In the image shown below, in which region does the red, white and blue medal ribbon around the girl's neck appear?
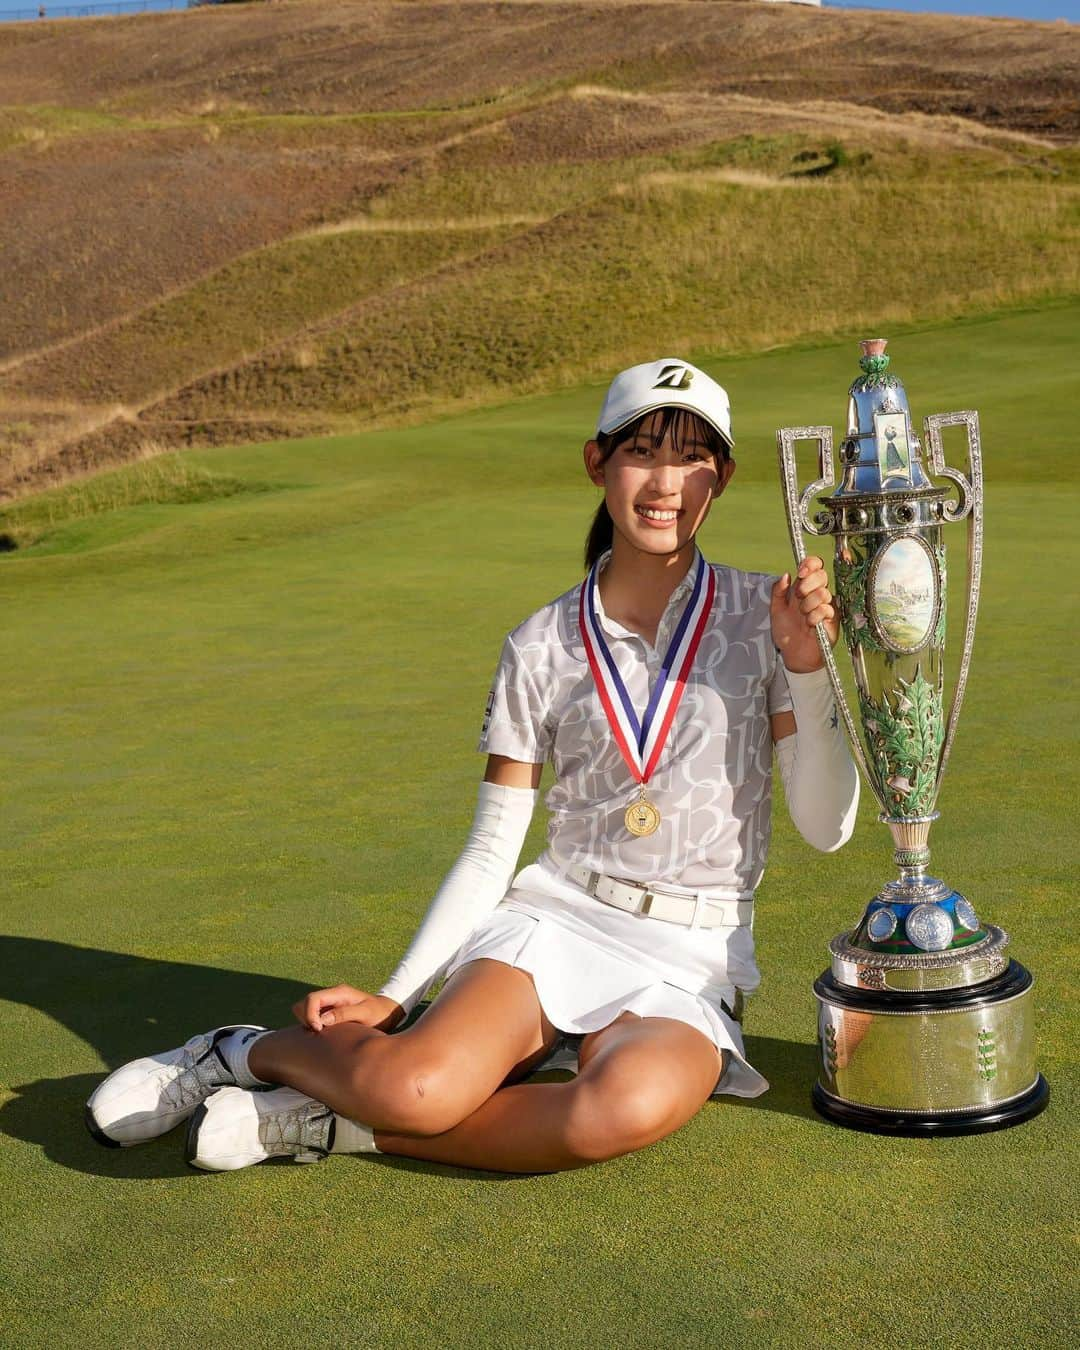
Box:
[578,554,717,787]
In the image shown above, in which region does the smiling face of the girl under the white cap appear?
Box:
[585,409,734,556]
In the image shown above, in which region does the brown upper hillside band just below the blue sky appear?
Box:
[0,0,1080,136]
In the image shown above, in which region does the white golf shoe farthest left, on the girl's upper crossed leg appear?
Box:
[86,1026,266,1149]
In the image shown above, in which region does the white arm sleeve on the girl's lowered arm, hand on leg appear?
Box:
[379,783,537,1013]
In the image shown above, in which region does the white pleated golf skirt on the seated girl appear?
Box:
[447,855,768,1098]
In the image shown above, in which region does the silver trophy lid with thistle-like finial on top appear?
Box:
[834,338,932,497]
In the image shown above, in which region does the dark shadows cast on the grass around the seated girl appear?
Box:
[0,936,817,1180]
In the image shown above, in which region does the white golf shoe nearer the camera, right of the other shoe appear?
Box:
[186,1088,336,1172]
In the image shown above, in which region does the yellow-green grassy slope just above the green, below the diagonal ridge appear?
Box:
[155,149,1080,415]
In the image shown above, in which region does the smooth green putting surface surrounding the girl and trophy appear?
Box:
[0,306,1077,1347]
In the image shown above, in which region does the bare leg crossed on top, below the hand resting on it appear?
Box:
[248,960,558,1134]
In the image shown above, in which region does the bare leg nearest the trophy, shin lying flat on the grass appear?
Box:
[375,1013,724,1172]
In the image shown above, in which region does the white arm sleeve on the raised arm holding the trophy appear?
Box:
[776,670,859,853]
